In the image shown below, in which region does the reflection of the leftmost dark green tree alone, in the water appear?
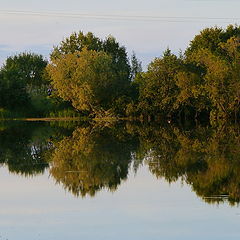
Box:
[0,123,49,176]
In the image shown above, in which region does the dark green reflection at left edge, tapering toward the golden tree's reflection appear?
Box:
[0,121,73,177]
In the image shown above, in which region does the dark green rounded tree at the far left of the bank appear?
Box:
[0,53,47,109]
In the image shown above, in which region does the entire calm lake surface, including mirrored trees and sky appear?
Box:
[0,122,240,240]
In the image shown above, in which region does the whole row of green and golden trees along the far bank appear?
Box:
[0,25,240,122]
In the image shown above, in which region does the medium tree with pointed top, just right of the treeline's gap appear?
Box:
[136,49,182,116]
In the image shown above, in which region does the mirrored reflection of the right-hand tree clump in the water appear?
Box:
[135,124,240,204]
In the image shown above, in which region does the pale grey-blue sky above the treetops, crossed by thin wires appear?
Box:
[0,0,240,66]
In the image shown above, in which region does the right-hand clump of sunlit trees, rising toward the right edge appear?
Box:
[133,25,240,121]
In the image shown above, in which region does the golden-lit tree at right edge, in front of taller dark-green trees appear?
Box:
[183,37,240,120]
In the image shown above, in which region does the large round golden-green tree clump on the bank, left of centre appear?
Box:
[48,32,131,116]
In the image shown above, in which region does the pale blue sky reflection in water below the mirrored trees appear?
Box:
[0,165,240,240]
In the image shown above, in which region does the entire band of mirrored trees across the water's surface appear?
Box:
[0,122,240,204]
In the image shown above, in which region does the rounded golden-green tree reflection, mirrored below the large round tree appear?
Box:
[50,126,137,196]
